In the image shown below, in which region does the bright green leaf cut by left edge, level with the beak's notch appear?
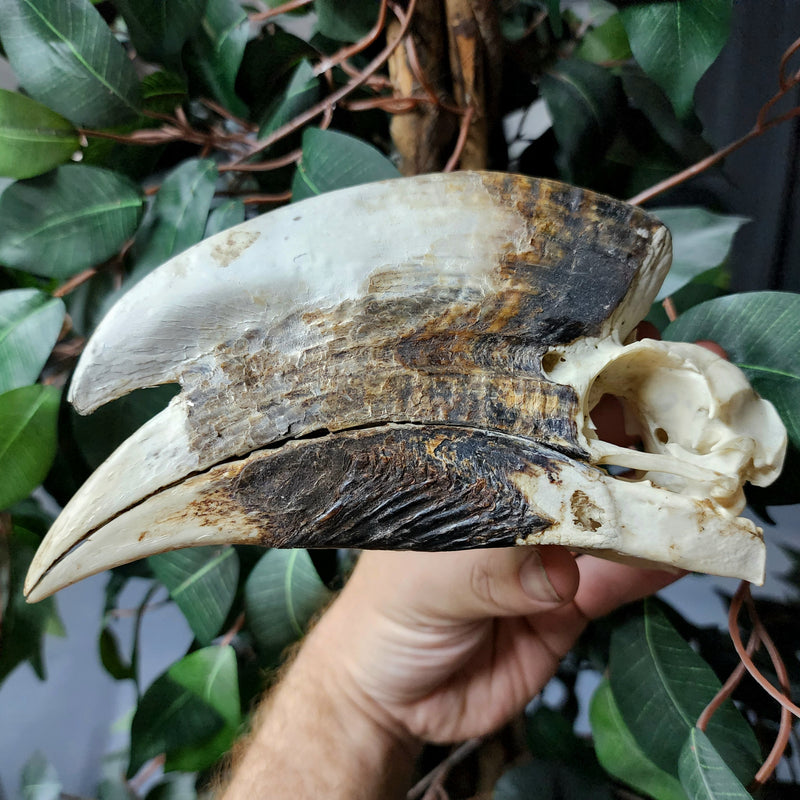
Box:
[0,384,61,510]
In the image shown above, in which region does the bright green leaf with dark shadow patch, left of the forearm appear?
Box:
[127,646,241,778]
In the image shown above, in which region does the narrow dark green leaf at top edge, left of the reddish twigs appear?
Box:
[186,0,250,116]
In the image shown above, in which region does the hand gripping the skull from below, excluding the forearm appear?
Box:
[315,547,677,742]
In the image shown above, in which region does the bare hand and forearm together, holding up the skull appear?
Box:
[225,547,676,800]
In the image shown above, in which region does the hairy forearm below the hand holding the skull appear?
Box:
[219,600,418,800]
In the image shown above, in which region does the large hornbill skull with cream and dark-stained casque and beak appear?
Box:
[26,173,786,600]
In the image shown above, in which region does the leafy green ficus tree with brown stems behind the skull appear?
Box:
[0,0,800,800]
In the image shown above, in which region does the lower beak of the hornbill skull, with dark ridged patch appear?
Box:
[21,424,764,601]
